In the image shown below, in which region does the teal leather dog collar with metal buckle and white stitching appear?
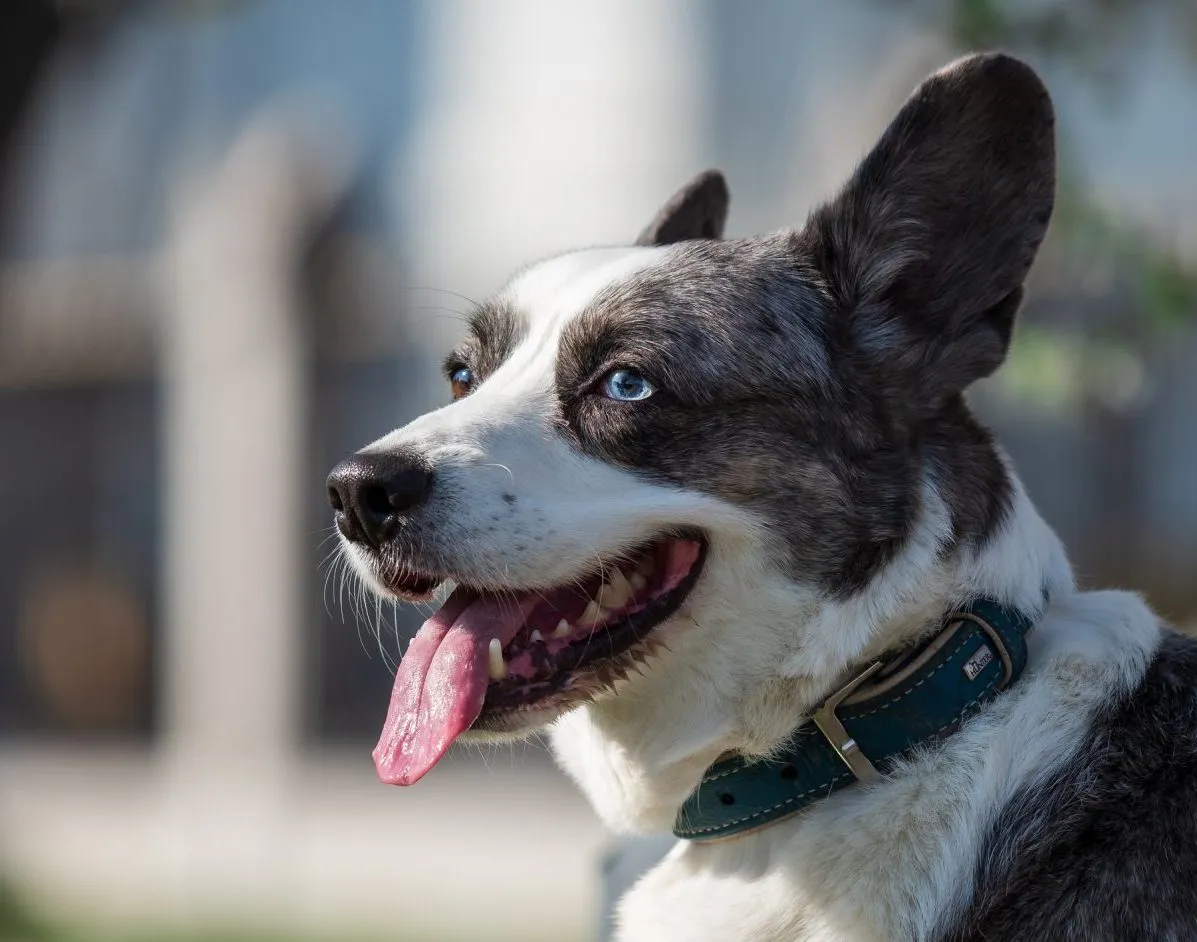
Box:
[674,598,1034,841]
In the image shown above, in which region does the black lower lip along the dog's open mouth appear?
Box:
[470,533,709,731]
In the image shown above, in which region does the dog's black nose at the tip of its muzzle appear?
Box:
[328,452,432,547]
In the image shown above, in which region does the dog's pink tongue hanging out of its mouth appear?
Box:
[373,589,539,785]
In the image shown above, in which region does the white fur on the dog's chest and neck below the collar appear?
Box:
[618,592,1160,942]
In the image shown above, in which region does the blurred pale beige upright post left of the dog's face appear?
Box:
[162,113,345,790]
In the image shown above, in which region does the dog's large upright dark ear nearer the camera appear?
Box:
[802,54,1056,406]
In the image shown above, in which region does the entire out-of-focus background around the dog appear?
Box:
[0,0,1197,942]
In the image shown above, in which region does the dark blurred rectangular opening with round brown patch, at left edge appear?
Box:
[0,382,159,737]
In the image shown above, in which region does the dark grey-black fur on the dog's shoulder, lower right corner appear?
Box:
[940,630,1197,942]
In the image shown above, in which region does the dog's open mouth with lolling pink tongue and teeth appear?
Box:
[373,535,706,785]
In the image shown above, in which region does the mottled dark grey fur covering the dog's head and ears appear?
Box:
[450,55,1055,595]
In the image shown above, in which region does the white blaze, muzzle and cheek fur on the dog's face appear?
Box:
[348,248,837,761]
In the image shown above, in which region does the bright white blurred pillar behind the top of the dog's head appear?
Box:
[395,0,710,361]
